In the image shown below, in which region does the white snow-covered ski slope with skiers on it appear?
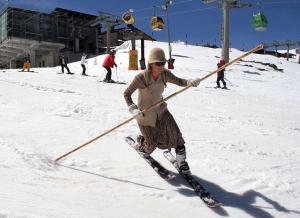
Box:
[0,42,300,218]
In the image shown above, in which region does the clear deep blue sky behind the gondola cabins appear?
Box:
[0,0,300,49]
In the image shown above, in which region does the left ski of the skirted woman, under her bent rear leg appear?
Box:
[125,136,176,181]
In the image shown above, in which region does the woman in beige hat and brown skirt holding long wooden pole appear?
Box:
[124,48,200,173]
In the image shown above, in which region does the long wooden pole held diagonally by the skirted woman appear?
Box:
[55,45,264,162]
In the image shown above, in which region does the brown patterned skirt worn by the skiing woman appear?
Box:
[139,110,185,154]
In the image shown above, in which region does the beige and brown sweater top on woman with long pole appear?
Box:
[124,69,187,127]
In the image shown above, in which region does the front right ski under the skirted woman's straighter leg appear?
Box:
[163,151,222,208]
